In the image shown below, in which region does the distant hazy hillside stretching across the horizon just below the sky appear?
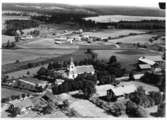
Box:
[2,3,165,17]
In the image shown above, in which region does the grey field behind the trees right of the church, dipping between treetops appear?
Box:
[94,49,158,70]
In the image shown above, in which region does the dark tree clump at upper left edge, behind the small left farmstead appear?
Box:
[2,20,39,36]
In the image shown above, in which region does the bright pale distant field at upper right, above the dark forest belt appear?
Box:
[85,15,165,23]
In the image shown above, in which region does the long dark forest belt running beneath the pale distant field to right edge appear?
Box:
[32,14,165,29]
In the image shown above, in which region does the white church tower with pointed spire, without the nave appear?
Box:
[68,57,78,79]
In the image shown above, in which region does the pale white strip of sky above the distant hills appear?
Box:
[2,0,165,8]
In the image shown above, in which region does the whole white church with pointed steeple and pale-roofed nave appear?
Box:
[68,58,95,79]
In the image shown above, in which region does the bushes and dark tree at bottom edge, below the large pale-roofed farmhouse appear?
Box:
[90,97,148,117]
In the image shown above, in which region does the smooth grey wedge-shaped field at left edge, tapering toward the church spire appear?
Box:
[2,49,74,65]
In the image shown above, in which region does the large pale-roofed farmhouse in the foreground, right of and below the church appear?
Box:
[96,84,137,98]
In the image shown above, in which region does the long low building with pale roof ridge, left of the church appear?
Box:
[14,78,47,90]
